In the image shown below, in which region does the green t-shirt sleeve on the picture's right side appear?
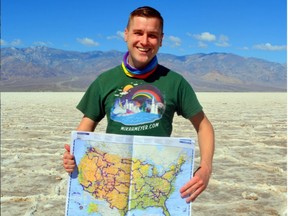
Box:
[177,78,203,119]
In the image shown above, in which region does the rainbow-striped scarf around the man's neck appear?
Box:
[122,52,158,79]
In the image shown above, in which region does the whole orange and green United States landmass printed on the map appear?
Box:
[78,148,185,216]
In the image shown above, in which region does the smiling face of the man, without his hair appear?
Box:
[124,16,163,69]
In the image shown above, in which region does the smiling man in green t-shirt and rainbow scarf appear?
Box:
[63,6,214,202]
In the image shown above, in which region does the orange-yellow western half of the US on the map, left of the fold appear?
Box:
[78,149,131,211]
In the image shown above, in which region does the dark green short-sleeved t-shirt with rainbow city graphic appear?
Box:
[77,65,202,136]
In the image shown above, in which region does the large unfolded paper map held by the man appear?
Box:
[65,131,194,216]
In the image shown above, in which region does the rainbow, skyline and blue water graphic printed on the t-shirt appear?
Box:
[110,84,165,125]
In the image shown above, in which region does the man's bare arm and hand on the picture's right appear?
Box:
[180,112,215,202]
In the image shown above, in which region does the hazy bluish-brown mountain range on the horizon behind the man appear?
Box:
[1,47,287,91]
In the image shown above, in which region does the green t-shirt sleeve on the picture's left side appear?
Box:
[76,79,105,122]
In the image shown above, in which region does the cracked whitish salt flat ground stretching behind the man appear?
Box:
[1,92,287,216]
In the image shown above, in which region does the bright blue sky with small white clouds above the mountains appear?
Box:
[1,0,287,63]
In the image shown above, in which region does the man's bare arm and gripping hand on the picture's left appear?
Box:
[63,116,98,173]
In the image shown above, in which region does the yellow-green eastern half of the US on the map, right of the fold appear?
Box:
[130,157,185,216]
